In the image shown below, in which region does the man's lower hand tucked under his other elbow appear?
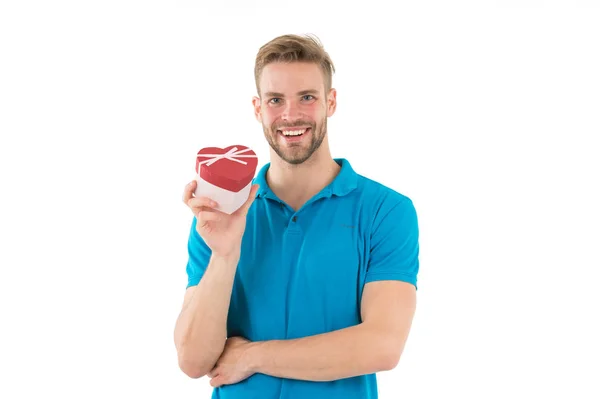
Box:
[207,337,254,388]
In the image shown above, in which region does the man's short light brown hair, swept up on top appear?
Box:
[254,34,335,97]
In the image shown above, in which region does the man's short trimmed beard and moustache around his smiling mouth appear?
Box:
[263,117,327,165]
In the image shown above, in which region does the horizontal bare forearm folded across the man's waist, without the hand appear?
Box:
[248,324,395,381]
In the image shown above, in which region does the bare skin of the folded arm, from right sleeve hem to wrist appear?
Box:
[247,281,416,381]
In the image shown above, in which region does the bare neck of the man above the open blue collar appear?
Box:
[266,148,340,210]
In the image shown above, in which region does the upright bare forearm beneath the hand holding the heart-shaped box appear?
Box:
[175,254,239,377]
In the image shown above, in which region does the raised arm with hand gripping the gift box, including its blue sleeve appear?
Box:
[174,180,258,378]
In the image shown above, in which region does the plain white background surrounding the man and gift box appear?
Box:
[0,0,600,399]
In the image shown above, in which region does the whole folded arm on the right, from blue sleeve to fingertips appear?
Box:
[209,197,419,386]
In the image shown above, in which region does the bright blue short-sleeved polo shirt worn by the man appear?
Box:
[186,159,419,399]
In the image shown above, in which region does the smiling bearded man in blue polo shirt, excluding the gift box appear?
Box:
[175,35,419,399]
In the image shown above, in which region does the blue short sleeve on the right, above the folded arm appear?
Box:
[365,197,419,288]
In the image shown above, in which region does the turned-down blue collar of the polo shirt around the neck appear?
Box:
[253,158,358,202]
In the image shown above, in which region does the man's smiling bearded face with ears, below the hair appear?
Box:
[254,62,335,164]
